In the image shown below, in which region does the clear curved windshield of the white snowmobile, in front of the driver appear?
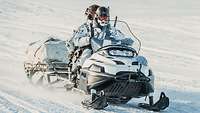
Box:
[91,20,141,53]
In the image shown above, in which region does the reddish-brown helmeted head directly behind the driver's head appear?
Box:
[85,4,99,20]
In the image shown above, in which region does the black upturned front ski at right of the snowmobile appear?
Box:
[138,92,169,112]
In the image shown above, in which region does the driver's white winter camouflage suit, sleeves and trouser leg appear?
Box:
[71,22,134,66]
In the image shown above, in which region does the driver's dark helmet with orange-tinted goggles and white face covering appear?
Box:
[96,7,109,26]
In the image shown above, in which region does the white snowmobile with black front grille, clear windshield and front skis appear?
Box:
[68,19,169,111]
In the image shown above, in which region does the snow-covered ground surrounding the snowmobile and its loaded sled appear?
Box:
[0,0,200,113]
